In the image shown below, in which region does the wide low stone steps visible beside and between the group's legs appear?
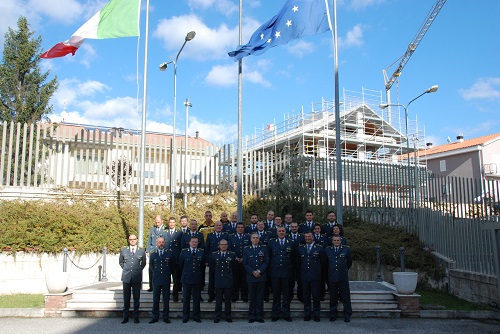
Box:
[61,281,401,319]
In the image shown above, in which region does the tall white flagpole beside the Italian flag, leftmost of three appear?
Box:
[137,0,149,247]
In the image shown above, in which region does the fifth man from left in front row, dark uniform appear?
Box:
[243,233,269,323]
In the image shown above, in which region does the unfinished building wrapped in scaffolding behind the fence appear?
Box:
[220,89,425,206]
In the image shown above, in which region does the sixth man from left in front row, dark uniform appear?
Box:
[267,226,295,322]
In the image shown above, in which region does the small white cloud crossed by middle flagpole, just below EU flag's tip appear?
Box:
[205,60,271,87]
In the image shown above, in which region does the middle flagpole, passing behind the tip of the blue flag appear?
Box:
[236,0,243,222]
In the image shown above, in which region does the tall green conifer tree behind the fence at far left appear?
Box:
[0,16,58,124]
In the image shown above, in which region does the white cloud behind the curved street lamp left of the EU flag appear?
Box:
[153,14,259,60]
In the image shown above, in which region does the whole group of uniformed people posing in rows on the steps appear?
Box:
[119,211,352,323]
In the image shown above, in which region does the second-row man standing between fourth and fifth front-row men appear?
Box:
[229,223,250,302]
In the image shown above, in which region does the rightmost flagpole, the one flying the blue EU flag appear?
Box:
[333,0,343,224]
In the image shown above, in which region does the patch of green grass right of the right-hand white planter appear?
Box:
[415,289,494,311]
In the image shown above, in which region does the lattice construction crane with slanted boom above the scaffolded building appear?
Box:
[382,0,446,123]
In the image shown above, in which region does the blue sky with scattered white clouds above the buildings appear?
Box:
[0,0,500,145]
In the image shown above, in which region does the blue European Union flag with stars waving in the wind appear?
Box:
[228,0,332,61]
